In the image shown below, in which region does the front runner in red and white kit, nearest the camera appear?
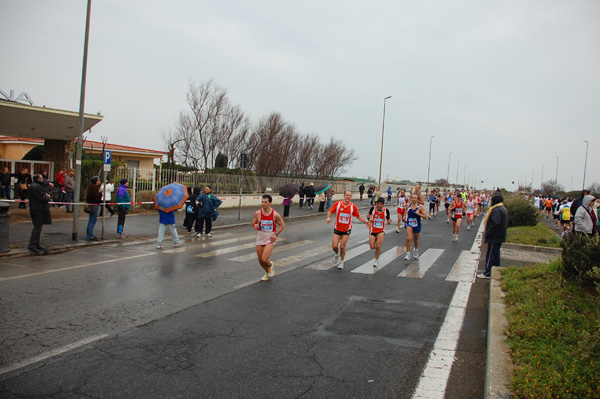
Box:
[252,194,285,281]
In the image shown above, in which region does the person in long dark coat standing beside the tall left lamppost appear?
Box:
[27,174,52,252]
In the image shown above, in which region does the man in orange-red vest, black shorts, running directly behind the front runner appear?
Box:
[327,191,369,270]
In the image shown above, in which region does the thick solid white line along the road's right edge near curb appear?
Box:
[413,223,484,399]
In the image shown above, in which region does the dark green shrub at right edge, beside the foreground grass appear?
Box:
[560,234,600,287]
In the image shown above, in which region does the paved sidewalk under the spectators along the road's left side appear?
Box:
[0,199,369,259]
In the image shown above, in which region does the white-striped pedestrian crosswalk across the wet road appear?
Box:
[161,233,479,282]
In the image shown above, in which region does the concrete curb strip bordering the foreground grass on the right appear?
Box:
[485,267,512,399]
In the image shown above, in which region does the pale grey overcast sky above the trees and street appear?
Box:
[0,0,600,190]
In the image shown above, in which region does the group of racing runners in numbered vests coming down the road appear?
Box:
[252,186,489,281]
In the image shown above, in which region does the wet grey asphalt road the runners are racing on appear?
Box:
[0,211,489,398]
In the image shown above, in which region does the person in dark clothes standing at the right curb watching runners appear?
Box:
[477,190,508,278]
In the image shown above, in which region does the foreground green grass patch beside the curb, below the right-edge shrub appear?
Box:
[502,260,600,398]
